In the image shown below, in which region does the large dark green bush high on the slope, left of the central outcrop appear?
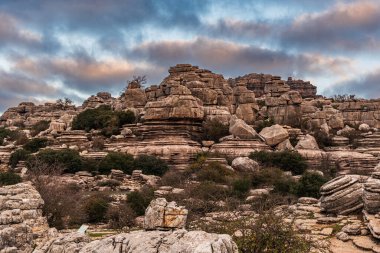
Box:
[72,105,136,137]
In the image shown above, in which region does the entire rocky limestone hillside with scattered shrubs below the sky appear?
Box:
[0,64,380,252]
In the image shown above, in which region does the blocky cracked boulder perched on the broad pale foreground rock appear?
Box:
[144,198,188,230]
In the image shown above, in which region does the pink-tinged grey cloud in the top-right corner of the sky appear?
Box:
[281,0,380,52]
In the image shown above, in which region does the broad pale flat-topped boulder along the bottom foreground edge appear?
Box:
[39,229,238,253]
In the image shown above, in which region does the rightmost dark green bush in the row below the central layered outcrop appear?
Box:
[134,155,169,176]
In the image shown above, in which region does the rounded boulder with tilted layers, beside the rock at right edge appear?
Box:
[320,175,363,215]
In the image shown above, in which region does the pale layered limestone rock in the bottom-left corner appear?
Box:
[0,183,49,253]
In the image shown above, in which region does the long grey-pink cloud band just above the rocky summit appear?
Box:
[128,38,351,76]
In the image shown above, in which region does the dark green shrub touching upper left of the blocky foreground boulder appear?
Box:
[127,187,154,215]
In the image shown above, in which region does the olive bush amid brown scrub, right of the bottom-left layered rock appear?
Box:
[84,195,109,222]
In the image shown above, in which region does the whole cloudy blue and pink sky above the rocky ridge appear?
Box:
[0,0,380,113]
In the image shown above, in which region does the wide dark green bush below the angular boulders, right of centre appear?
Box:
[249,151,307,175]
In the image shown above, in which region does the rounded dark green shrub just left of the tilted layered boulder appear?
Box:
[296,172,327,198]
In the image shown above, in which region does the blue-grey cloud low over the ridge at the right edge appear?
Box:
[326,69,380,98]
